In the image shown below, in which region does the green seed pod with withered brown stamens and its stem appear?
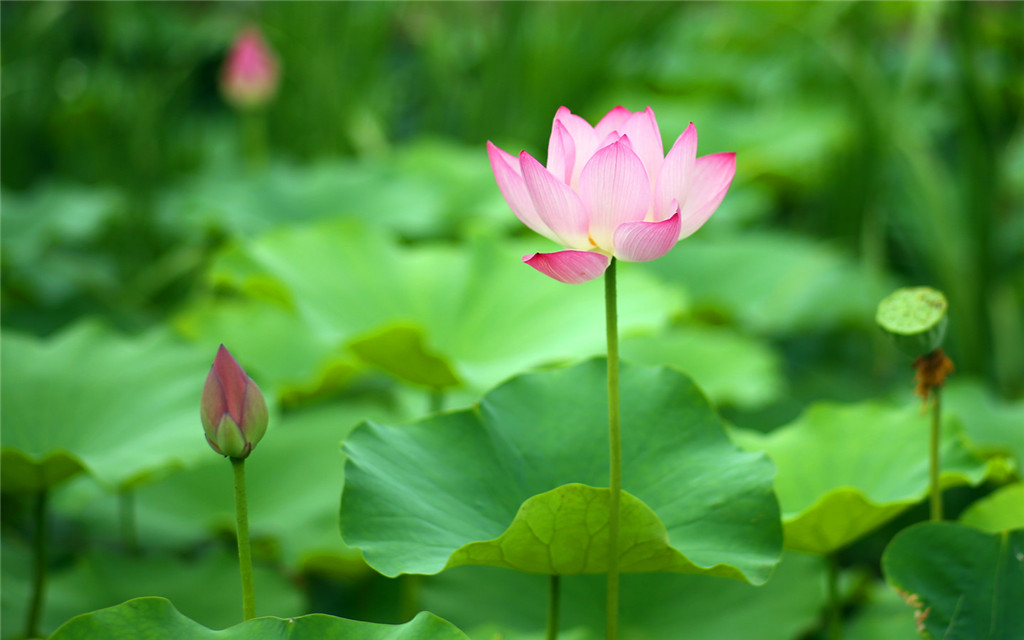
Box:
[876,287,953,521]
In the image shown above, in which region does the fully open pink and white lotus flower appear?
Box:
[487,106,736,285]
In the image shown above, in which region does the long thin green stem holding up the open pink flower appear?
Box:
[604,258,623,640]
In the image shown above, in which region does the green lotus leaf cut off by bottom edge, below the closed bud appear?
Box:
[50,598,466,640]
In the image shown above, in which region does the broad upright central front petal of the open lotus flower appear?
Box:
[580,136,650,253]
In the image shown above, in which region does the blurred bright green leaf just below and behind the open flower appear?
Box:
[204,220,681,390]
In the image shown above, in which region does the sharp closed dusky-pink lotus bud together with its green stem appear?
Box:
[200,345,268,620]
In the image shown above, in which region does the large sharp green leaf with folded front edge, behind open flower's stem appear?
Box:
[341,359,780,584]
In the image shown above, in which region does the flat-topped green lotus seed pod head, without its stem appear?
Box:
[874,287,947,357]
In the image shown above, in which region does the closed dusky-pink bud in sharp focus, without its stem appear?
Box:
[200,345,269,458]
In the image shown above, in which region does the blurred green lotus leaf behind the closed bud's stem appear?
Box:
[55,401,394,572]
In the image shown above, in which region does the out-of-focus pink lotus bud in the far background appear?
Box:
[220,27,281,110]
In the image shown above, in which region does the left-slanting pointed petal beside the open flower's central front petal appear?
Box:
[519,152,591,249]
